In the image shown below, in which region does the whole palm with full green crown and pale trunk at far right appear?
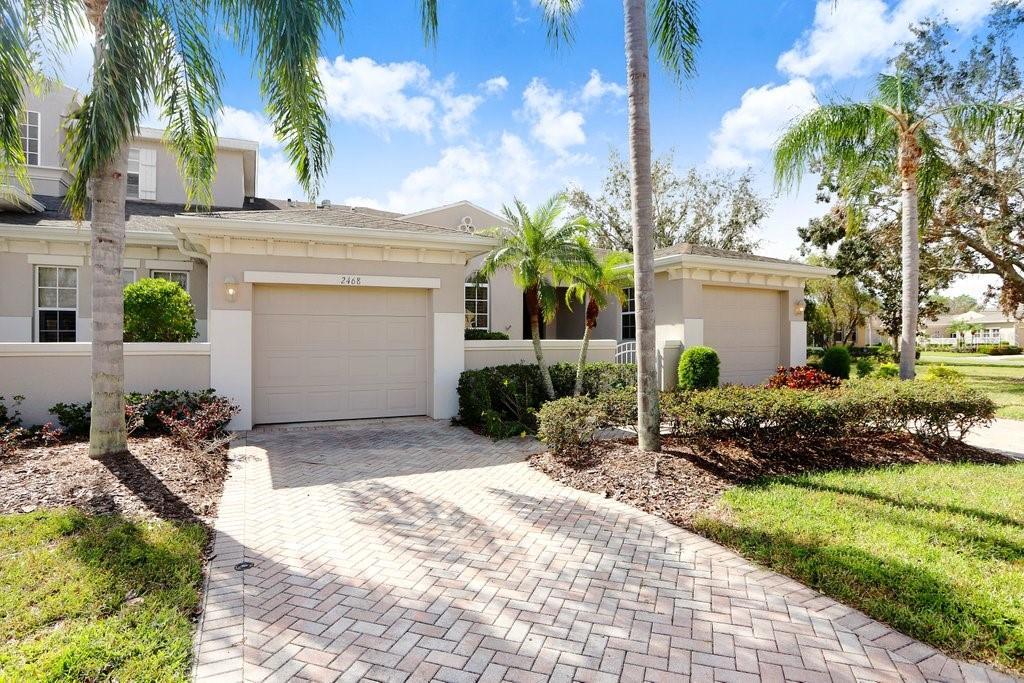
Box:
[775,69,1024,379]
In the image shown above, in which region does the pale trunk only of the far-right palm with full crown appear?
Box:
[899,133,921,380]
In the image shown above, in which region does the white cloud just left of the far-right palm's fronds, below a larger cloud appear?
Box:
[708,78,817,168]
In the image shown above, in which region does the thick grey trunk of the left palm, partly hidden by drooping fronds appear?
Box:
[86,0,128,458]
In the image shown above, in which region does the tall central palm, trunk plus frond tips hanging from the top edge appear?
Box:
[540,0,700,452]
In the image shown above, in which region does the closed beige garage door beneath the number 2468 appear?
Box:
[253,285,429,424]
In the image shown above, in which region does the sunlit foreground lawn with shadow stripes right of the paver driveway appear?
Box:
[695,463,1024,674]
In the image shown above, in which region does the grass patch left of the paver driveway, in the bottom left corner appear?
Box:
[0,510,206,681]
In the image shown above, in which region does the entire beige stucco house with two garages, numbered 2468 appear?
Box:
[0,82,831,429]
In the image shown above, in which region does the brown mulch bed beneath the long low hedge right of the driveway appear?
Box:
[530,434,1008,527]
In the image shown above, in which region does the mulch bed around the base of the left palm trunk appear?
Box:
[0,437,227,524]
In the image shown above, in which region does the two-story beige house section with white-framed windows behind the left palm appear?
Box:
[0,84,271,342]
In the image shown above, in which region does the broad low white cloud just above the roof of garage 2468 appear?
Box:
[366,131,543,212]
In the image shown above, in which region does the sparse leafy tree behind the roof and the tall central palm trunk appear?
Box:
[566,151,771,253]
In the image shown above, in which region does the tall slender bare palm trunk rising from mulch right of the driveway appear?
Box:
[623,0,662,452]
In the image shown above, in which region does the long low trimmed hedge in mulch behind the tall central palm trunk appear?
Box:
[539,379,995,457]
